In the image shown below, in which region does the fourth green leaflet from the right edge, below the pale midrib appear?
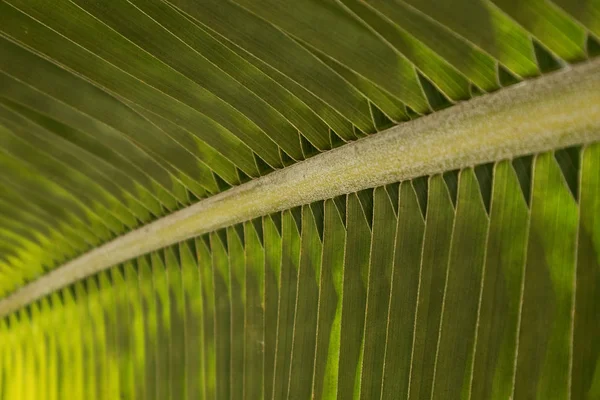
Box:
[432,168,489,399]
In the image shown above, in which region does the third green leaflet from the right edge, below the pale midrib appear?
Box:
[471,161,529,399]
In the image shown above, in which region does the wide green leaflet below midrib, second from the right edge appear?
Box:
[514,153,579,399]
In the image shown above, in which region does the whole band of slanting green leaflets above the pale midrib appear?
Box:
[0,0,600,296]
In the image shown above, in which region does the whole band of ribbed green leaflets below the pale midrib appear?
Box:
[0,143,600,399]
